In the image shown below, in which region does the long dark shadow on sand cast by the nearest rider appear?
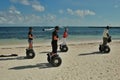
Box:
[9,63,53,70]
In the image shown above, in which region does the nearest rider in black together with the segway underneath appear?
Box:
[47,26,62,67]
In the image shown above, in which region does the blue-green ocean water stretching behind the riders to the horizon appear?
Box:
[0,26,120,45]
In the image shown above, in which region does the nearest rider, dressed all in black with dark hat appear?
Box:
[51,26,59,55]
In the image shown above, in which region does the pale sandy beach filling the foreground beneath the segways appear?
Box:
[0,40,120,80]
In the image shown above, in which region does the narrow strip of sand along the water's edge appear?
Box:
[0,40,120,49]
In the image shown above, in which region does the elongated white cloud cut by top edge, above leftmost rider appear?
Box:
[10,0,45,12]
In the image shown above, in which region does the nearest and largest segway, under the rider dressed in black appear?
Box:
[47,53,62,67]
